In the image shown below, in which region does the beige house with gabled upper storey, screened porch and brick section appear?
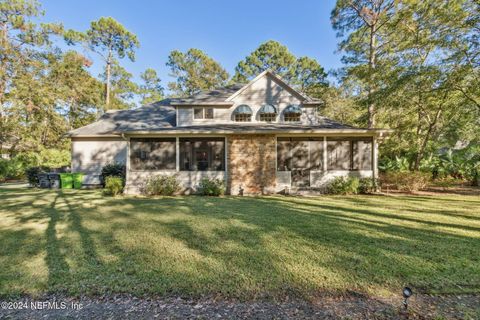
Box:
[70,71,387,194]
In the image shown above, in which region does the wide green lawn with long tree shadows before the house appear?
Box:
[0,189,480,299]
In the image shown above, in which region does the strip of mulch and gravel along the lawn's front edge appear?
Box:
[0,295,480,320]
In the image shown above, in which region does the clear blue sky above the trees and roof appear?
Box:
[41,0,341,87]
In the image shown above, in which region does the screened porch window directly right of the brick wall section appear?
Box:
[277,137,323,171]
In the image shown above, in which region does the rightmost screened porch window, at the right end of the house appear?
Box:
[327,138,372,170]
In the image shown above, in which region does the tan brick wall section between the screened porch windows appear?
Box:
[227,135,276,195]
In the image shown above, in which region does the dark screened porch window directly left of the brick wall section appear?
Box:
[180,138,225,171]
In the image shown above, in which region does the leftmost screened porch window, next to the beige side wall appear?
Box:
[130,138,177,170]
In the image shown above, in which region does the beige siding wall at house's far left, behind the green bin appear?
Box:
[72,138,127,184]
